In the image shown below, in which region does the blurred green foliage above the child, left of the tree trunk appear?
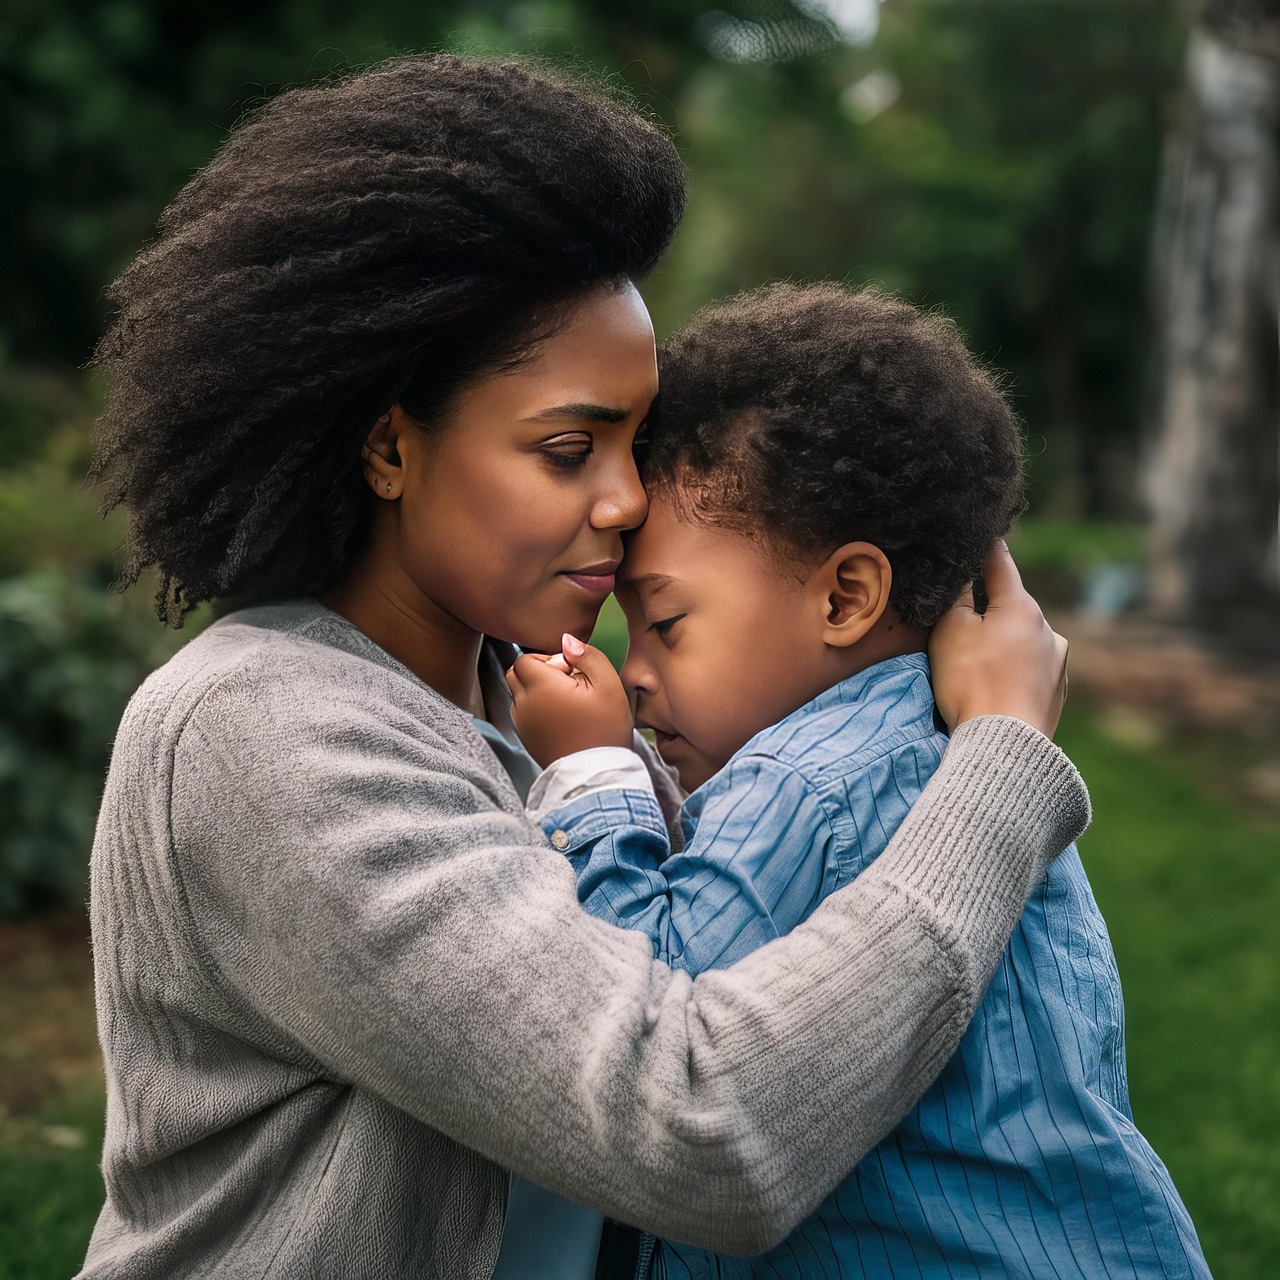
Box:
[663,0,1181,515]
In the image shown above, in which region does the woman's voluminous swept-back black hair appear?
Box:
[91,54,685,626]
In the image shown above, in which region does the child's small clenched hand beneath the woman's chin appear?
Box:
[507,635,634,769]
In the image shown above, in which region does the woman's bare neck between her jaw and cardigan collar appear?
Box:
[319,557,485,717]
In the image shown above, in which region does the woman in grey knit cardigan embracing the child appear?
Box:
[83,56,1087,1280]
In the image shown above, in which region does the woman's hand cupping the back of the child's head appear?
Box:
[929,538,1066,737]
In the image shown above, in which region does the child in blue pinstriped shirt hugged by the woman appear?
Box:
[511,285,1208,1280]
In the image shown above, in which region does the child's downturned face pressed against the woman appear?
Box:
[617,493,827,791]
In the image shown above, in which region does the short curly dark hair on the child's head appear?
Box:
[645,284,1023,626]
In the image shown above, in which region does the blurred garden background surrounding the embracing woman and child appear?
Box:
[0,0,1280,1277]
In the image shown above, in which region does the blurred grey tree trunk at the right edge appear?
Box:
[1147,0,1280,643]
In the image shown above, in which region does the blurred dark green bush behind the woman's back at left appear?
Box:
[0,572,189,915]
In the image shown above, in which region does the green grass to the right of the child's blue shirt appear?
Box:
[1059,708,1280,1280]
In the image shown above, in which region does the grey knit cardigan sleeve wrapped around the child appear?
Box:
[169,655,1088,1253]
